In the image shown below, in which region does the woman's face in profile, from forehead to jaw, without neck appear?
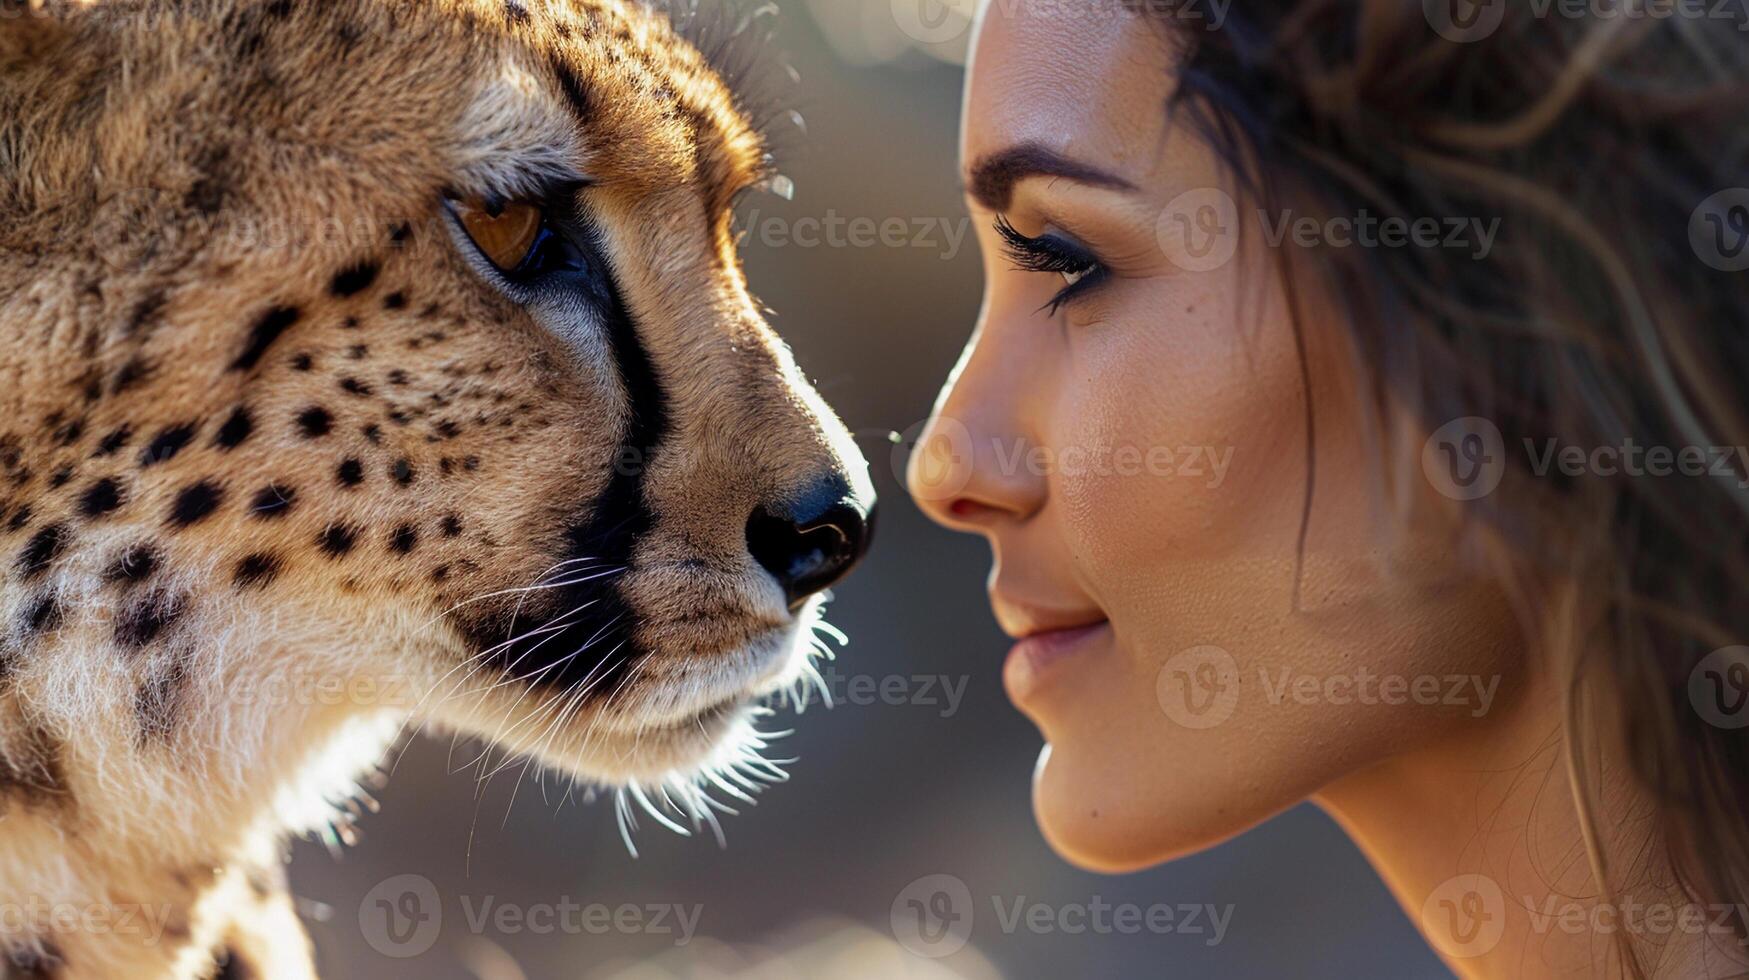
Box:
[911,4,1522,870]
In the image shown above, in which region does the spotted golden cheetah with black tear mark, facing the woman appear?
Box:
[0,0,875,980]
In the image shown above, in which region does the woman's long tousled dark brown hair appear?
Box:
[1125,0,1749,975]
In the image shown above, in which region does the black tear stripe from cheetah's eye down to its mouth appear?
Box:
[458,252,670,698]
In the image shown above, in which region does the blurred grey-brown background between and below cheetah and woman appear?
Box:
[292,0,1450,980]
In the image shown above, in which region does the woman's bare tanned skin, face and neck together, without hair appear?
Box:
[911,5,1742,978]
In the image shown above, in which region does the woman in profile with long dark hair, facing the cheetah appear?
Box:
[911,0,1749,978]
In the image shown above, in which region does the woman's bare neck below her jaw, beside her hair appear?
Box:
[1315,679,1749,980]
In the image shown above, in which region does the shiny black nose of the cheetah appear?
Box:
[747,478,875,609]
